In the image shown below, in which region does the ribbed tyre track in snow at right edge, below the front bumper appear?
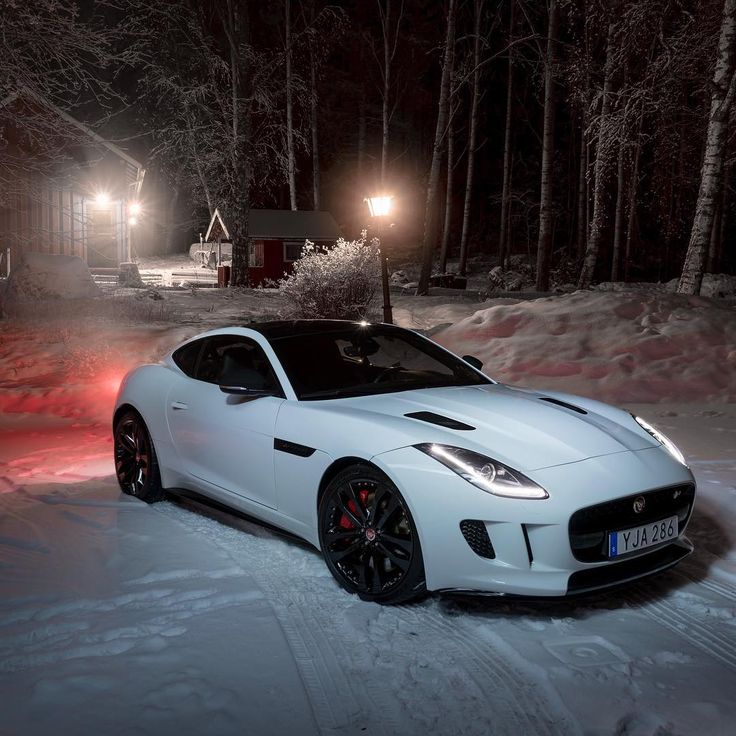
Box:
[625,593,736,672]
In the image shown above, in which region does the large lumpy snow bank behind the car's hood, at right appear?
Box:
[433,292,736,403]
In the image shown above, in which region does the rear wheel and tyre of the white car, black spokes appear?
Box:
[113,410,165,503]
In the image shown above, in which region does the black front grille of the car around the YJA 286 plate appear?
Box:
[568,483,695,562]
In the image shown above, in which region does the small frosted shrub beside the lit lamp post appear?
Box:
[279,231,379,319]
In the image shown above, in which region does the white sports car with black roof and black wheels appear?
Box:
[113,320,695,603]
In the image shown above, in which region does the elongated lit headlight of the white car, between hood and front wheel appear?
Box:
[414,442,549,499]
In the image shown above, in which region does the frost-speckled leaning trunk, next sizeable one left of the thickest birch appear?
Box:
[578,13,619,289]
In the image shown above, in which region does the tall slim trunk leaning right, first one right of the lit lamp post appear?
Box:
[417,0,455,295]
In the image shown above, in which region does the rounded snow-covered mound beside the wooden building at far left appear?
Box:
[4,253,100,304]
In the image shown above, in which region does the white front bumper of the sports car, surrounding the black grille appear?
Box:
[372,447,694,596]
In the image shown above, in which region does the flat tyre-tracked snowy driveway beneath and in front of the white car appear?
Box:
[0,405,736,736]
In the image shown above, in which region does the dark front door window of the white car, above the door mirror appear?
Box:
[194,335,283,396]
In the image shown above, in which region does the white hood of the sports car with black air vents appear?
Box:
[323,384,659,470]
